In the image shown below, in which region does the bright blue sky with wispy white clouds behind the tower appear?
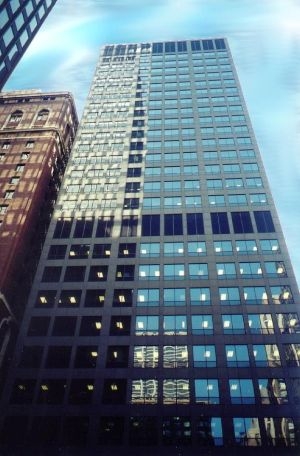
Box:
[5,0,300,283]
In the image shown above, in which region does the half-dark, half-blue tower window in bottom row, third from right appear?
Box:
[195,416,223,447]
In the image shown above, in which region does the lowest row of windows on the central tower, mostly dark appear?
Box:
[1,416,299,451]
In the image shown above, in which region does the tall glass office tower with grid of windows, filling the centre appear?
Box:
[1,39,300,455]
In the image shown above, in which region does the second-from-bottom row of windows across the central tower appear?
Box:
[10,376,297,405]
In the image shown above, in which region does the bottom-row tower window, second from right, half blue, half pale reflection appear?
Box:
[233,418,261,446]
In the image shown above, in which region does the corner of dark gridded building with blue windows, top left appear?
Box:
[0,0,56,90]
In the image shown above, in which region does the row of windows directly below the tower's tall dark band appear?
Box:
[48,239,280,260]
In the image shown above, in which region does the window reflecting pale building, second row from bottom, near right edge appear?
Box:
[258,378,288,405]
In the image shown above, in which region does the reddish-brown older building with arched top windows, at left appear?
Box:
[0,91,78,390]
